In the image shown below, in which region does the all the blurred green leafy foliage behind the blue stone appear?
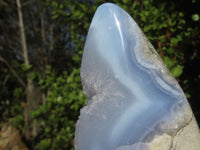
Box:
[0,0,200,150]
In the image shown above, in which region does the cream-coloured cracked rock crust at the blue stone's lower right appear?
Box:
[148,117,200,150]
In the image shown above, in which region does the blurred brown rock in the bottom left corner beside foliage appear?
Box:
[0,124,28,150]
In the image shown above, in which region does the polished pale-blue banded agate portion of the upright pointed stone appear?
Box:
[75,3,191,150]
